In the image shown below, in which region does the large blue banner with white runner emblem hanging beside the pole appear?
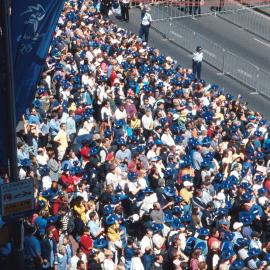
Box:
[11,0,65,121]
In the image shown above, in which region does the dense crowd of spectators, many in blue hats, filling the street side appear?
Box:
[0,0,270,270]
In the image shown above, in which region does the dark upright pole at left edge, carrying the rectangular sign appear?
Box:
[0,0,24,270]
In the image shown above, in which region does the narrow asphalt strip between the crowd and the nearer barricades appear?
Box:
[111,9,270,121]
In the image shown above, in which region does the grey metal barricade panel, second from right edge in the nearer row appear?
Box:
[223,51,259,89]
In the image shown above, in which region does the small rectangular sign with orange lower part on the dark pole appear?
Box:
[0,180,35,219]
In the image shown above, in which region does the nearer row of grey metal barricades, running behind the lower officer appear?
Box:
[153,20,270,98]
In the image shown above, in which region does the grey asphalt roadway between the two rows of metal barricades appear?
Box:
[149,6,270,72]
